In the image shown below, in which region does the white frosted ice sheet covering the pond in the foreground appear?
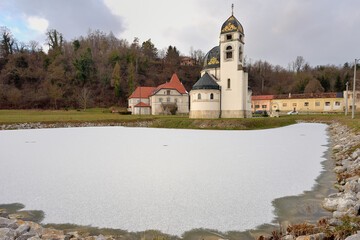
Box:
[0,123,328,234]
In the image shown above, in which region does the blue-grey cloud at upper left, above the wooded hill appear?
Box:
[7,0,124,40]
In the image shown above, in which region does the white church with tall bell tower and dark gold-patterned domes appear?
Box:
[189,9,252,118]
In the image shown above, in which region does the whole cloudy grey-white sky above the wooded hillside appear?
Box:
[0,0,360,67]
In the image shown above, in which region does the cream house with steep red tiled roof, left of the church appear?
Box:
[128,73,189,115]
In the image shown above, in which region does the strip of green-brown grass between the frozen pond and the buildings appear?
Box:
[0,108,360,132]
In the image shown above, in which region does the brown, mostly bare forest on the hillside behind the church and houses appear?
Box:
[0,27,354,109]
